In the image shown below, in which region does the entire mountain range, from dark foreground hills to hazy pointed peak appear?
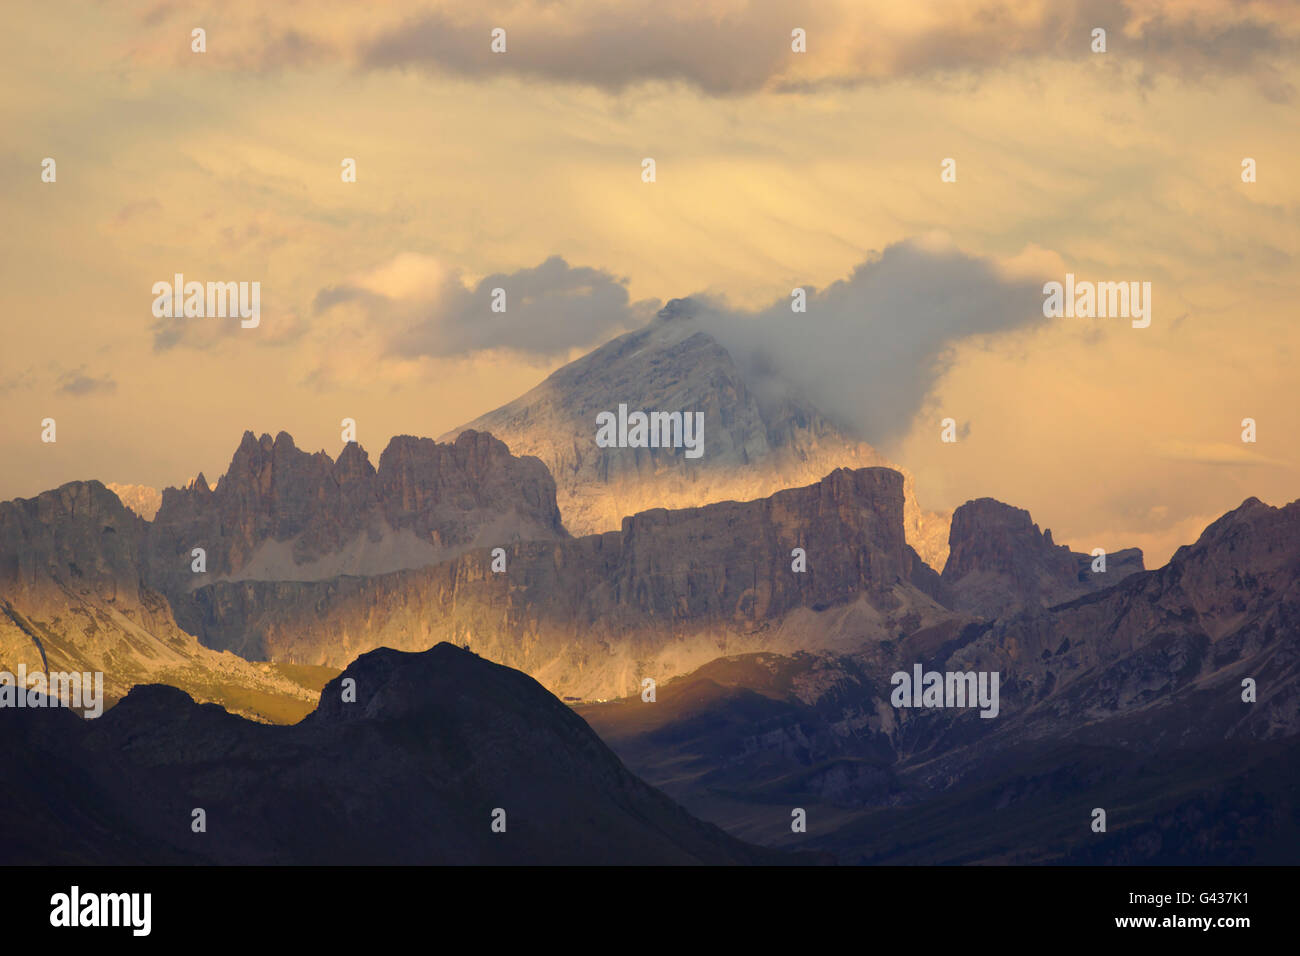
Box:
[0,310,1300,862]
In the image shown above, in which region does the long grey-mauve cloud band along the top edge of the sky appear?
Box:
[360,0,1297,99]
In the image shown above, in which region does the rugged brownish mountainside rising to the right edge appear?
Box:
[949,498,1300,747]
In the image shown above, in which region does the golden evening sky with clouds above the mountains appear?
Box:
[0,0,1300,567]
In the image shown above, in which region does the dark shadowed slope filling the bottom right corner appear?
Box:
[801,737,1300,866]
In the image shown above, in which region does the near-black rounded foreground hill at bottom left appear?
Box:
[0,644,818,865]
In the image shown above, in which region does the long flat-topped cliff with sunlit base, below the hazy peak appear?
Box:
[179,468,948,697]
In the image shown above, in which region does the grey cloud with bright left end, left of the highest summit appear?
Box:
[312,255,659,359]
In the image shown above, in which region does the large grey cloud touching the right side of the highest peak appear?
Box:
[692,239,1045,444]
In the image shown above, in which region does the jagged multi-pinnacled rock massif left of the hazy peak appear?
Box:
[150,432,564,600]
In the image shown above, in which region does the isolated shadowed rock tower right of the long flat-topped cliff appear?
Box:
[943,498,1143,618]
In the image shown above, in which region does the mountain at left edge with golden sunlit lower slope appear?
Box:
[0,481,325,719]
